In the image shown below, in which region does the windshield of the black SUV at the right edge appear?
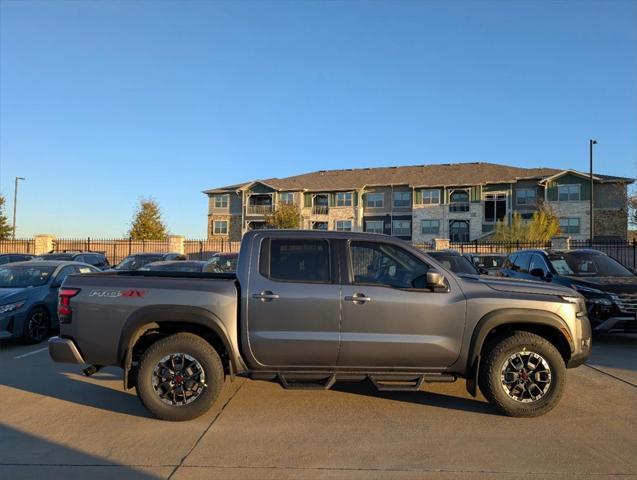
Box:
[549,252,634,277]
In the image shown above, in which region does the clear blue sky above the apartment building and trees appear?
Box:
[0,0,637,237]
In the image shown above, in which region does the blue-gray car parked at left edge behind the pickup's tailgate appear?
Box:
[0,260,100,343]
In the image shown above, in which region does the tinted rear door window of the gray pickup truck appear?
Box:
[259,238,331,283]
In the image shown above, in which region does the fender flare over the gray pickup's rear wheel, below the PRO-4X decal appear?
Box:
[117,305,237,375]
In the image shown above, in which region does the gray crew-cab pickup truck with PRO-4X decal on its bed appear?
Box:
[49,230,591,420]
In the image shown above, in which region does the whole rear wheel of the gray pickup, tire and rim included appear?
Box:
[137,333,224,421]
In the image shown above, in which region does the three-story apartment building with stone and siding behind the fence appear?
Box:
[204,163,633,243]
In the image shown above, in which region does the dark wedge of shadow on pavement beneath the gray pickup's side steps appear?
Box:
[332,382,498,416]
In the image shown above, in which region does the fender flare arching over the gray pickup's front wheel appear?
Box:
[466,308,575,396]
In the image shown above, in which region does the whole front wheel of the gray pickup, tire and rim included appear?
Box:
[478,331,566,417]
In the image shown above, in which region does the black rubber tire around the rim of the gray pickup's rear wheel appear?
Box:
[136,333,224,422]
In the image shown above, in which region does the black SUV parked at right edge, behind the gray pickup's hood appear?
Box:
[501,248,637,332]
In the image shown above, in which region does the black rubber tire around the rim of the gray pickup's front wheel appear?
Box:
[478,331,566,417]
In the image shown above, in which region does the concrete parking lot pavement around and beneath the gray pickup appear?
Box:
[0,335,637,480]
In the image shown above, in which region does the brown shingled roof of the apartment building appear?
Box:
[204,162,633,194]
